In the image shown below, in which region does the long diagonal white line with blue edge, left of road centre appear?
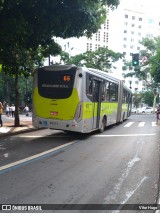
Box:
[0,141,76,171]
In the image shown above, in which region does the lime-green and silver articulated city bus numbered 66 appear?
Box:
[32,65,132,133]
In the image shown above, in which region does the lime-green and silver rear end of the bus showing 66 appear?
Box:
[33,65,83,132]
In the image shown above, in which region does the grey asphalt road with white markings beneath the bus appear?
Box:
[0,115,160,213]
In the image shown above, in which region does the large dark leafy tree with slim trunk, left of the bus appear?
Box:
[0,0,119,126]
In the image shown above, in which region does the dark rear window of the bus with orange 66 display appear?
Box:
[38,68,76,99]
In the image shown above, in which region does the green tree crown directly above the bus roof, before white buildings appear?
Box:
[61,47,123,72]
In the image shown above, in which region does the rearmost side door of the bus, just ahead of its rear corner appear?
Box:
[93,79,102,129]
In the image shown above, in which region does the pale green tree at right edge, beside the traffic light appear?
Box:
[123,36,160,109]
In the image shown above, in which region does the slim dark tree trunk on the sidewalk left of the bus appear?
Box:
[14,68,20,127]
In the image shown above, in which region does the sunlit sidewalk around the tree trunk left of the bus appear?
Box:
[0,114,36,137]
